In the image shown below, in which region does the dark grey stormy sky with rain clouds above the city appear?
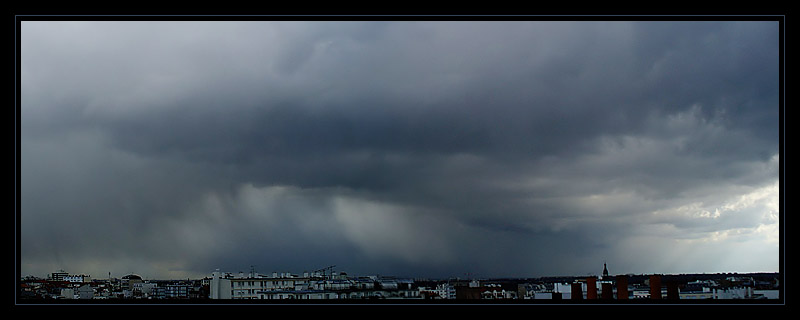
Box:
[20,21,780,279]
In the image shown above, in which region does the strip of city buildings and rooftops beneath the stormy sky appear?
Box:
[18,266,782,304]
